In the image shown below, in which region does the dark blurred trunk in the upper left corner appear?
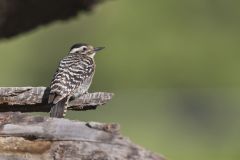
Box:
[0,0,102,38]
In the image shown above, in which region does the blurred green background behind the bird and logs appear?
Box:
[0,0,240,160]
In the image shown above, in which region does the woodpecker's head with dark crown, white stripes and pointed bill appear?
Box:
[70,43,104,58]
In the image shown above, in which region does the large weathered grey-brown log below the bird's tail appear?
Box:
[0,112,164,160]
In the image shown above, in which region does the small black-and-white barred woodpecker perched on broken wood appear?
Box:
[48,43,105,118]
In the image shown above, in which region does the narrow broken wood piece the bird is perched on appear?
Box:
[0,87,113,112]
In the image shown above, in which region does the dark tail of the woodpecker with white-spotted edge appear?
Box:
[50,97,68,118]
